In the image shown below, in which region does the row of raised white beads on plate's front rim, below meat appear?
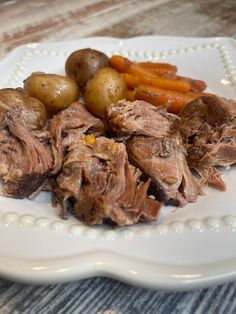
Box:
[0,212,236,240]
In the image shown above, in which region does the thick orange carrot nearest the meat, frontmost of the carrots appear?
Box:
[134,85,202,113]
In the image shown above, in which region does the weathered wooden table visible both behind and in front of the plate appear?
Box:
[0,0,236,314]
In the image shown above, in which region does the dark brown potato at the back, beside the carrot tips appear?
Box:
[65,48,109,90]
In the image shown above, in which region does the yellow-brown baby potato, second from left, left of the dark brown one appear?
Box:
[24,72,80,113]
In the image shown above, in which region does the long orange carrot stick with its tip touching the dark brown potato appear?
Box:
[110,55,190,93]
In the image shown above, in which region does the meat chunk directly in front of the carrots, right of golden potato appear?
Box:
[104,100,178,140]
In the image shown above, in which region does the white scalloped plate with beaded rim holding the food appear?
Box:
[0,37,236,290]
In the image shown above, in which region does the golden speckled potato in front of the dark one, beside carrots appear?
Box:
[84,68,126,118]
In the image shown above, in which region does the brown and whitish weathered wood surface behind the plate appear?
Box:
[0,0,236,57]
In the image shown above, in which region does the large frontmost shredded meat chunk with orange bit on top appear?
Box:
[53,135,160,226]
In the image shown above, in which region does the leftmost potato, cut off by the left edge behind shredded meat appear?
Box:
[0,88,48,129]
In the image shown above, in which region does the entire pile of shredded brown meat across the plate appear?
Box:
[0,96,236,225]
